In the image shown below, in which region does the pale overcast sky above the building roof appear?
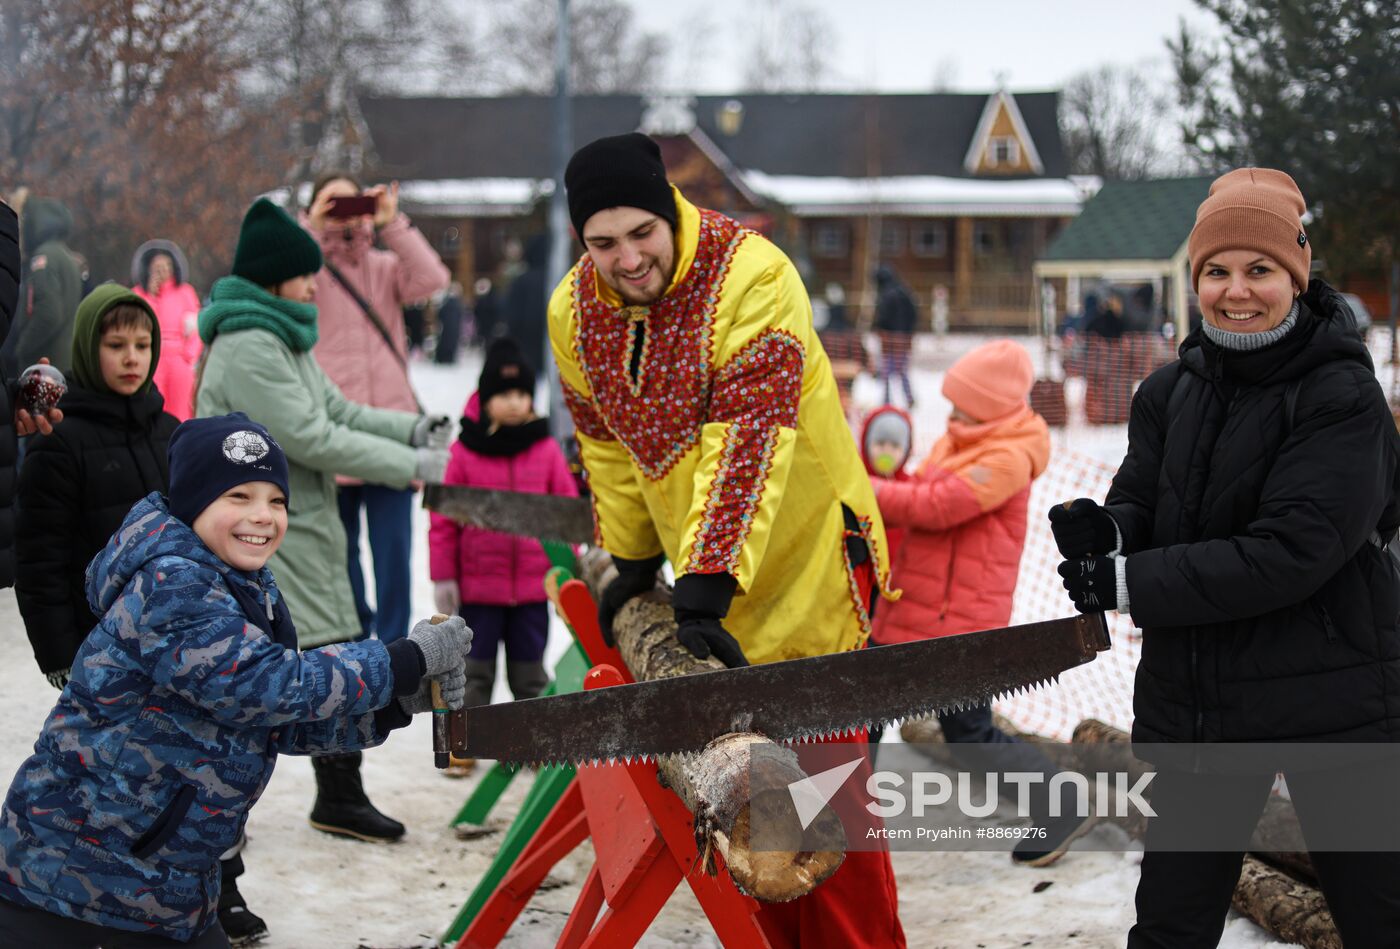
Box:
[633,0,1218,94]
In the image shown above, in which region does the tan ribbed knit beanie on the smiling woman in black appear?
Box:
[1186,168,1312,290]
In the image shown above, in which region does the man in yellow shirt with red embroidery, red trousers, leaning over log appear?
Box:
[549,133,904,946]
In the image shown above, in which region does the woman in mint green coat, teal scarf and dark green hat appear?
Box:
[195,199,452,867]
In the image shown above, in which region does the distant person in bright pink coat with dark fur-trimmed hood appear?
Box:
[132,241,204,421]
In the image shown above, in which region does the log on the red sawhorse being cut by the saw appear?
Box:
[580,549,846,903]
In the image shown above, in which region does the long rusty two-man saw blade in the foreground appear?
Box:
[454,613,1110,764]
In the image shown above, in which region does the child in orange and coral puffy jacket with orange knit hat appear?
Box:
[871,340,1092,866]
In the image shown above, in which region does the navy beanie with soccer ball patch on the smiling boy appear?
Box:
[165,412,291,526]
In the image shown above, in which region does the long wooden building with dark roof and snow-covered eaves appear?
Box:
[360,90,1098,329]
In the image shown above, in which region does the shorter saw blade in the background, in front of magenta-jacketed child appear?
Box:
[423,484,594,543]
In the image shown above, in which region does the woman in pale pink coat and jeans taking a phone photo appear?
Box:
[302,172,451,642]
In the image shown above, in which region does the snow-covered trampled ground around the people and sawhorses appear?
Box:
[0,337,1310,949]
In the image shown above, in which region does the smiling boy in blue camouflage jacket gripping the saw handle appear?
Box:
[0,413,472,949]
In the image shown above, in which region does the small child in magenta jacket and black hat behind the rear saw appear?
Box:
[428,339,578,708]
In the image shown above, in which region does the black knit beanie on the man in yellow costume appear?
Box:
[564,132,676,241]
